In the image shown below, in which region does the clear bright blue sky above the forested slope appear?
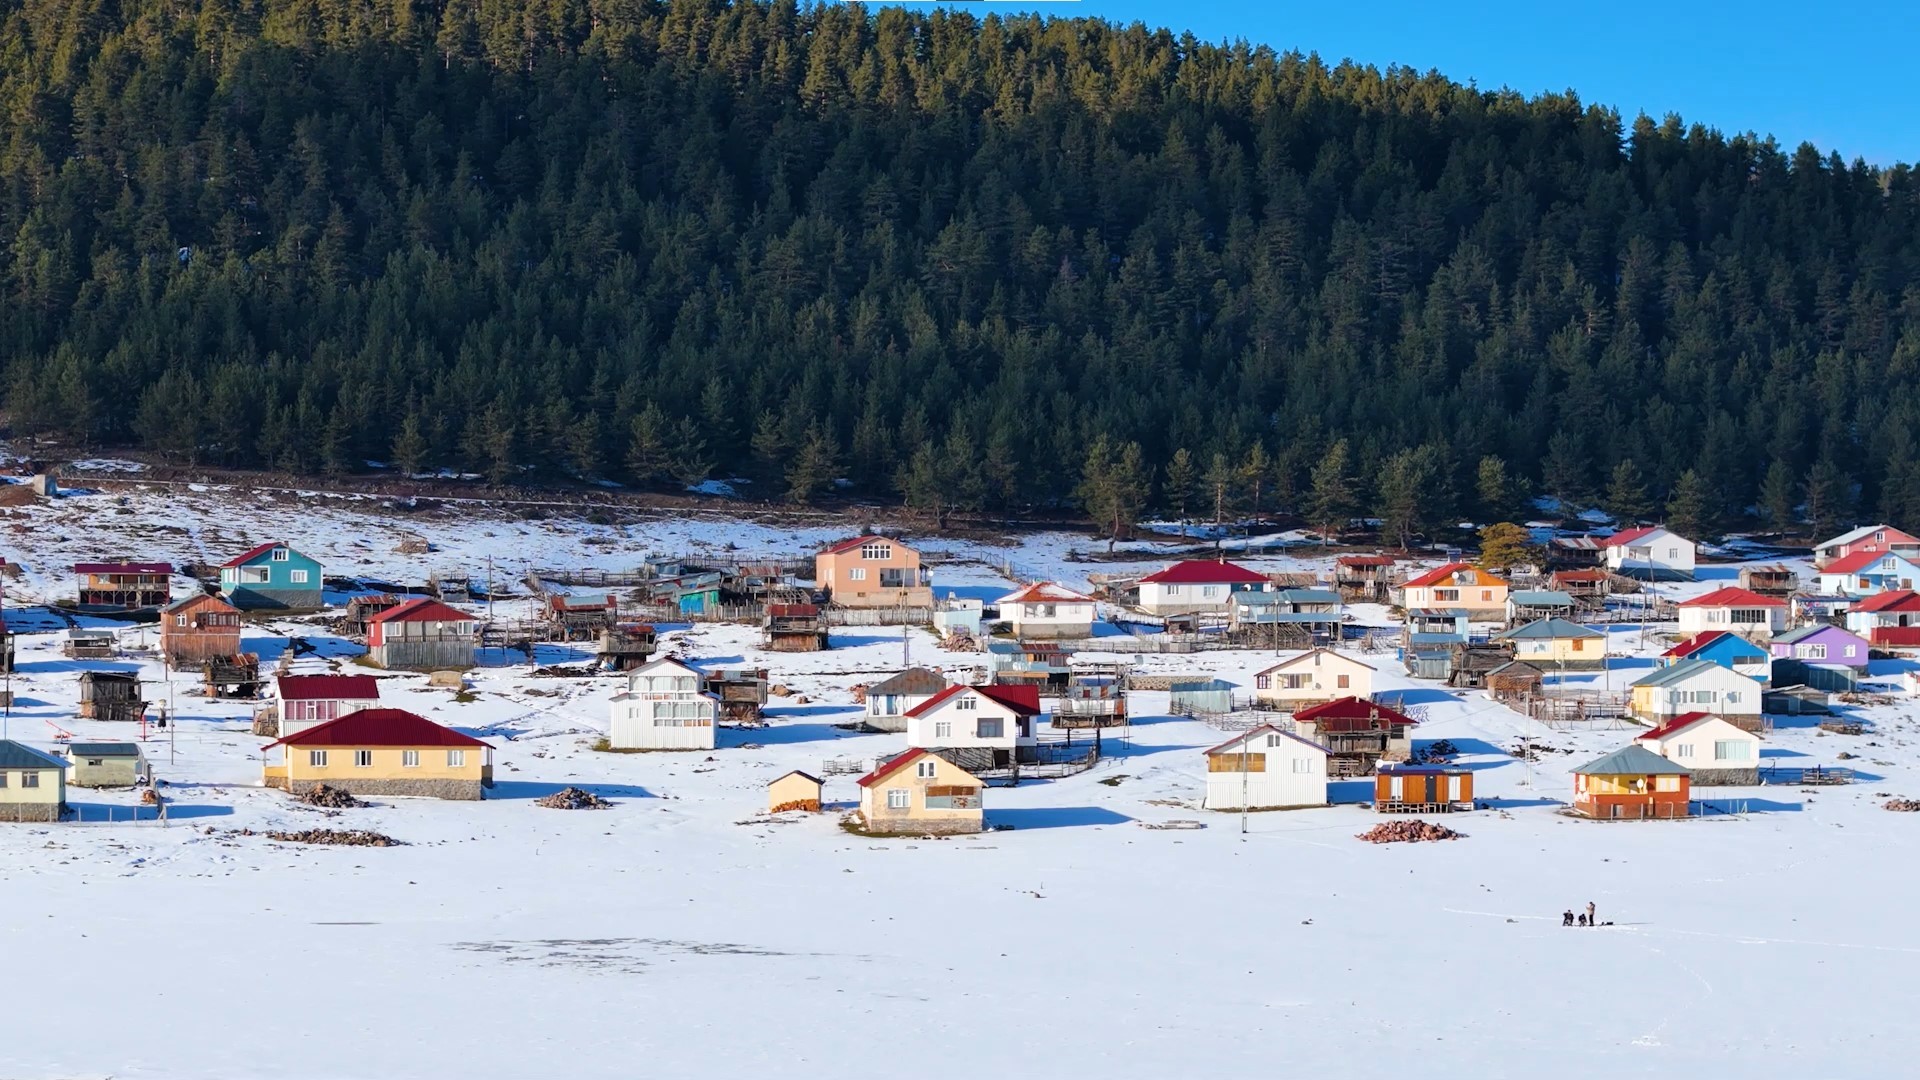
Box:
[879,0,1920,165]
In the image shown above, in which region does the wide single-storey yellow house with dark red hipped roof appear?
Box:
[261,709,493,799]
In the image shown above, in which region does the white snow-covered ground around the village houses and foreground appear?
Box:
[0,480,1920,1078]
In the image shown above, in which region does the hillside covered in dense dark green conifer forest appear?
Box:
[0,0,1920,528]
